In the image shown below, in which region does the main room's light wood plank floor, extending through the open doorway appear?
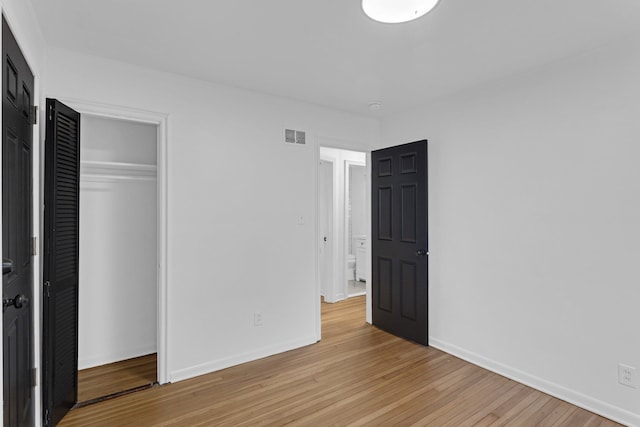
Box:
[60,297,619,427]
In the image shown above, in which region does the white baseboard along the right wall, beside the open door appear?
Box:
[429,337,640,427]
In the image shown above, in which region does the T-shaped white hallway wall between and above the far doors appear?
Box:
[320,149,366,303]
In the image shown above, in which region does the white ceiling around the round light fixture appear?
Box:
[31,0,640,115]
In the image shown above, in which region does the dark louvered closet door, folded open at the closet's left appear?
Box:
[43,99,80,425]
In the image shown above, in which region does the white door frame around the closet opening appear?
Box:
[48,97,169,384]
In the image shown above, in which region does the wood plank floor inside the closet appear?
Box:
[78,354,157,403]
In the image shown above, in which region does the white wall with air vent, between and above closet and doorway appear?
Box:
[46,48,379,381]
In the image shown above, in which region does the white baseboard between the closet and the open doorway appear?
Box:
[169,336,318,382]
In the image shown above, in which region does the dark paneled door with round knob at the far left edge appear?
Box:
[2,17,34,426]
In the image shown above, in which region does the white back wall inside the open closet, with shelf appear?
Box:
[78,115,158,369]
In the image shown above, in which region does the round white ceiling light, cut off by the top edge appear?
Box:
[362,0,438,24]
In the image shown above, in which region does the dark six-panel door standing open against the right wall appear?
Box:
[371,141,429,345]
